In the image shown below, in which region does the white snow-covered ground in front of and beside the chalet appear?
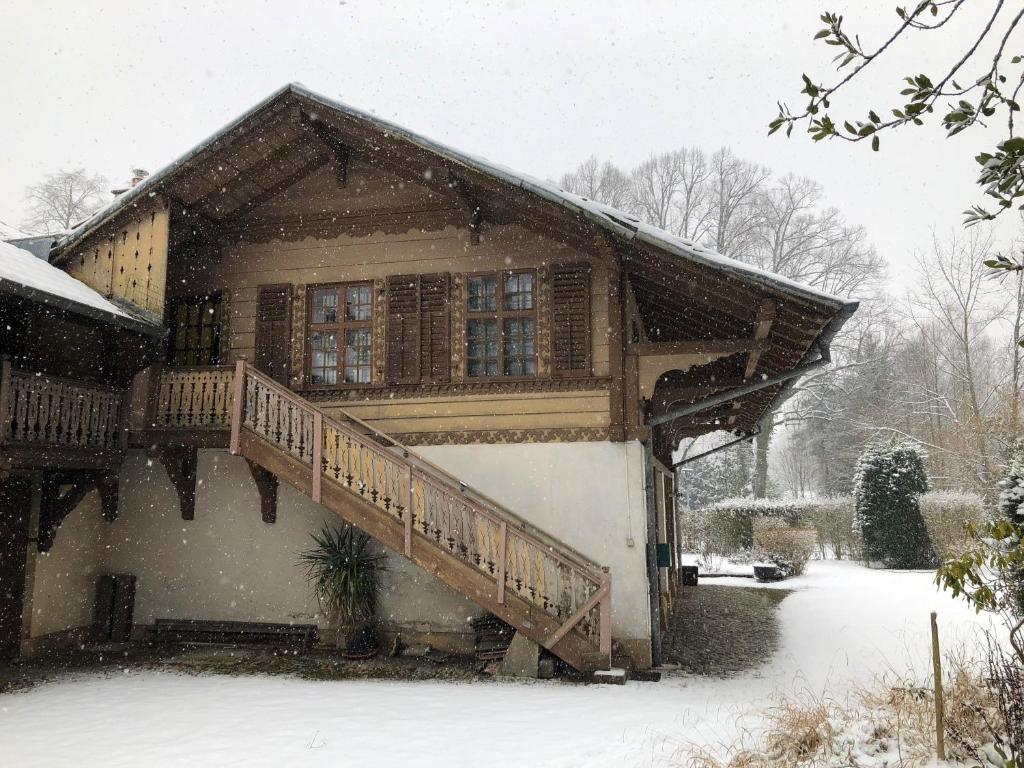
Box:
[0,561,1003,768]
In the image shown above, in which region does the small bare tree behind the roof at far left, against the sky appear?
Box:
[23,168,110,234]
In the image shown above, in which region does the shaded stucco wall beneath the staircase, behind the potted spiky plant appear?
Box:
[105,451,479,631]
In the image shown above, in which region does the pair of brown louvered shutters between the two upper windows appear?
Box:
[386,272,452,383]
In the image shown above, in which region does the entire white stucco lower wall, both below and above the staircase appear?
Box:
[33,442,650,659]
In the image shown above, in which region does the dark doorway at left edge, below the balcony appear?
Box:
[0,475,32,657]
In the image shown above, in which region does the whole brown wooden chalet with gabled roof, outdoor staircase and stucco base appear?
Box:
[0,85,855,670]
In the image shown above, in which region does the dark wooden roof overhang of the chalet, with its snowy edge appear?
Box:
[51,83,857,432]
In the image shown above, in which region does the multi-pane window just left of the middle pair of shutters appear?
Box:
[309,283,373,386]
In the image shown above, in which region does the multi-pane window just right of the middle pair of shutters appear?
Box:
[466,271,537,378]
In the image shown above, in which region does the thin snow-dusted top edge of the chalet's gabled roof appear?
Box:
[55,83,856,314]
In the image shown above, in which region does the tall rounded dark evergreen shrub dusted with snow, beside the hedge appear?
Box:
[854,440,935,568]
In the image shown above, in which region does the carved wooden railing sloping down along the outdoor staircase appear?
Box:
[230,360,611,657]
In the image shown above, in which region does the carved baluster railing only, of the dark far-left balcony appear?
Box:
[0,359,126,453]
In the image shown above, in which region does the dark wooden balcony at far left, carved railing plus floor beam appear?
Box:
[0,359,127,470]
